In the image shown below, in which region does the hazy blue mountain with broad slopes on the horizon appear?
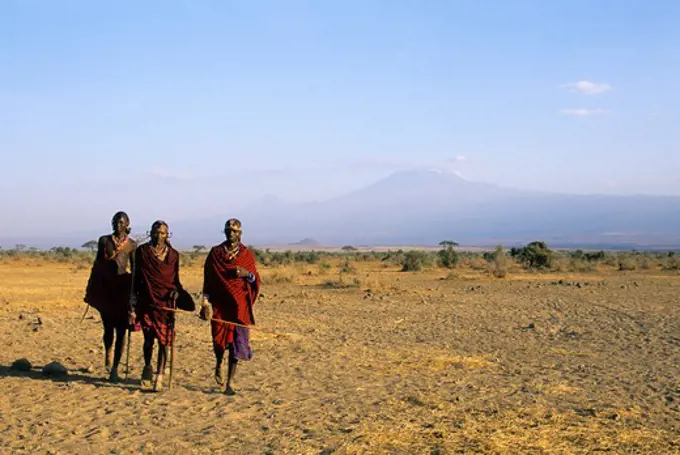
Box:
[2,171,680,248]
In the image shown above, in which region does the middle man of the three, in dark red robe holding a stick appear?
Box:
[133,220,183,391]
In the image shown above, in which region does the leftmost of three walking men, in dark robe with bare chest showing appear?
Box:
[83,212,137,382]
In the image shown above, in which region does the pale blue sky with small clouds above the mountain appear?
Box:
[0,0,680,239]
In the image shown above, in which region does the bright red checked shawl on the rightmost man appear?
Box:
[203,242,261,349]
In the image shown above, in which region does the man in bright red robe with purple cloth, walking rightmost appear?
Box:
[200,218,261,395]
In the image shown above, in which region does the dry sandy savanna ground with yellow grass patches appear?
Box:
[0,249,680,454]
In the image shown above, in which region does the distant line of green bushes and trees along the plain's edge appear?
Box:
[0,241,680,277]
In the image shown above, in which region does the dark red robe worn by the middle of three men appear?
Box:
[134,243,182,346]
